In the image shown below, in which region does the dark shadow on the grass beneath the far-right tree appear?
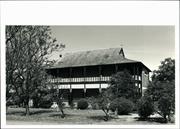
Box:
[135,117,167,123]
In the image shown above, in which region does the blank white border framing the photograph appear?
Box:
[0,1,180,128]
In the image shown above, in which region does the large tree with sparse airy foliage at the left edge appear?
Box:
[6,26,62,115]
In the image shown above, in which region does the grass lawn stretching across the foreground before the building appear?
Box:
[6,108,173,125]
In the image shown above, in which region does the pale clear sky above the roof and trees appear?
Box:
[51,26,175,71]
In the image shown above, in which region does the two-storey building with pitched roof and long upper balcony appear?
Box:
[47,48,151,103]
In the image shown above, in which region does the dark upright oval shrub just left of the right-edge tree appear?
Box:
[137,96,154,119]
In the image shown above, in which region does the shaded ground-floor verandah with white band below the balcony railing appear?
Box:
[51,83,142,105]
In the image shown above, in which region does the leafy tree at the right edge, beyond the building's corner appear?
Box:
[146,81,175,121]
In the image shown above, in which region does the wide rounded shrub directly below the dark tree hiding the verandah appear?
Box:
[109,98,134,115]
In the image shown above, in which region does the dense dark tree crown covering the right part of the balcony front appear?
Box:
[108,70,135,100]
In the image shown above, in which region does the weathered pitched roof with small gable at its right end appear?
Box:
[47,48,150,71]
